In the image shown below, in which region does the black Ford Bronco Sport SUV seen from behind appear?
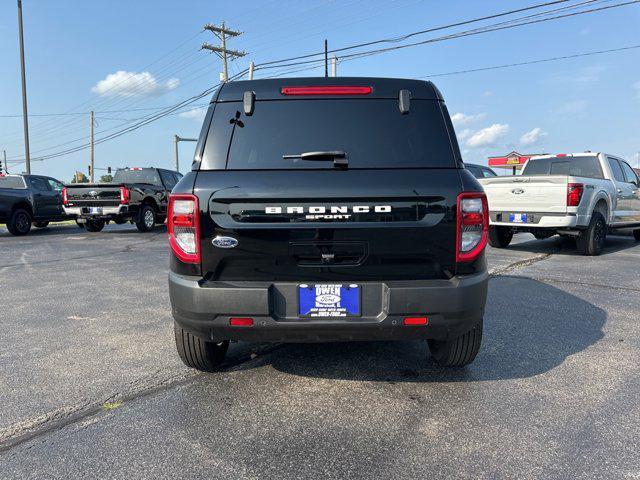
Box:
[168,78,488,371]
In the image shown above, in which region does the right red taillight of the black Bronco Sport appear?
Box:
[456,192,489,262]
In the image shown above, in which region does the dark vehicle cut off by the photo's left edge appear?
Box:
[0,174,66,235]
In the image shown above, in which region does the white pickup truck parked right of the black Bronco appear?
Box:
[479,152,640,255]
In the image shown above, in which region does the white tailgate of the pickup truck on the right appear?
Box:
[480,175,568,213]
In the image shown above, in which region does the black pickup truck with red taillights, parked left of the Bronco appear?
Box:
[63,167,182,232]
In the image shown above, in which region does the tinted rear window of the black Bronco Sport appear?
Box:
[200,99,456,170]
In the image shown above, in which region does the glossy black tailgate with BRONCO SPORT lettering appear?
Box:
[194,169,461,281]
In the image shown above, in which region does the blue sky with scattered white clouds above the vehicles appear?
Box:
[0,0,640,181]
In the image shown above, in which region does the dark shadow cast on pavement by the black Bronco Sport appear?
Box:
[234,276,607,382]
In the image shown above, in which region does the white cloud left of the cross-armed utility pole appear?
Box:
[91,70,180,97]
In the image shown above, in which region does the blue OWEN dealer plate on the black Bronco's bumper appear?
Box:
[298,283,362,318]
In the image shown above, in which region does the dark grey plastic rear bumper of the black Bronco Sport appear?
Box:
[169,272,488,342]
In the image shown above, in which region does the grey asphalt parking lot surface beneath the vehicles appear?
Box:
[0,226,640,479]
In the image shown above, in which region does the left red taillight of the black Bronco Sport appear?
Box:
[167,193,200,263]
